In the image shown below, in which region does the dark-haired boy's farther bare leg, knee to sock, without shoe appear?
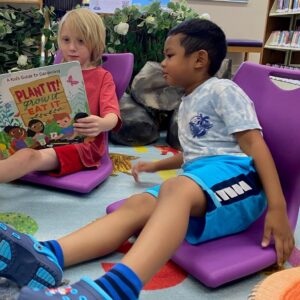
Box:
[58,193,157,267]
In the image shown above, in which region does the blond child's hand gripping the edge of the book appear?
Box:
[73,115,104,137]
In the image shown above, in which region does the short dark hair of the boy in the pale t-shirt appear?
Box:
[168,19,227,76]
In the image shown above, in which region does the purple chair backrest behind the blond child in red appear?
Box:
[54,51,134,99]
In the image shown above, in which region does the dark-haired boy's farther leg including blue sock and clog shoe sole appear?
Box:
[0,194,156,287]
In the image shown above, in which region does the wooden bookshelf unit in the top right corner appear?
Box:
[261,0,300,66]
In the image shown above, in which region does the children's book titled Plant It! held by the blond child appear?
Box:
[0,62,89,159]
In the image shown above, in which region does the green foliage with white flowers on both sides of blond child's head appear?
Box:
[0,0,205,76]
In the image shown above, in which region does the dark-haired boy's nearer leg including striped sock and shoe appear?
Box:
[19,176,206,300]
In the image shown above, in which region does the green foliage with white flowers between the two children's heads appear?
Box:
[104,1,199,76]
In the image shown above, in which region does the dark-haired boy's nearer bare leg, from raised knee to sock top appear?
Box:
[122,176,206,283]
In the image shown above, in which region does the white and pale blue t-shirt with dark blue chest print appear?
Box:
[178,77,261,162]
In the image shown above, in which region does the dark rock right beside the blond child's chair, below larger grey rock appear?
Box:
[110,94,159,146]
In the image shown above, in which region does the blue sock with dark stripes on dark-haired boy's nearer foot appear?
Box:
[95,263,143,300]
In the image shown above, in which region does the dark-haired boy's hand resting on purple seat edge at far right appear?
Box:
[261,209,295,266]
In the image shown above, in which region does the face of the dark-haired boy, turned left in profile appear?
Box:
[161,34,209,93]
